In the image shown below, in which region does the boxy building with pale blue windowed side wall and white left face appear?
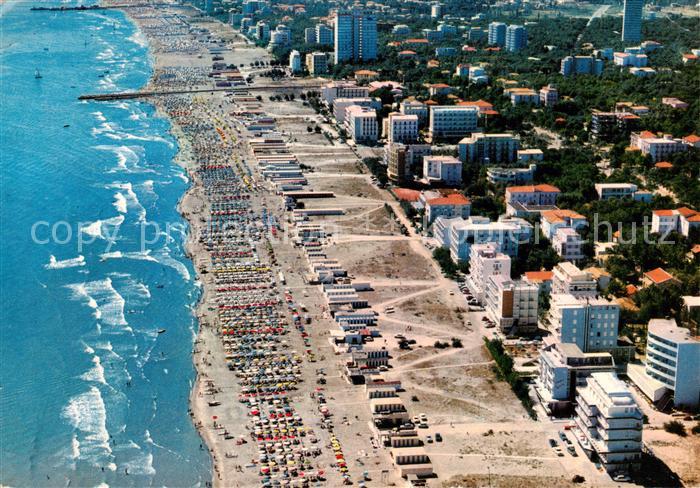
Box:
[549,293,620,352]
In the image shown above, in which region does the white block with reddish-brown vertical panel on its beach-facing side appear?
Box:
[484,275,539,333]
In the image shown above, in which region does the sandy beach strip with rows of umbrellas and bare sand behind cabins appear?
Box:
[86,2,700,487]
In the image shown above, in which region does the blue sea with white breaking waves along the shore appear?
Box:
[0,1,211,486]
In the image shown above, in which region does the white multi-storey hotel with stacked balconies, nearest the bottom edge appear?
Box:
[575,372,642,473]
